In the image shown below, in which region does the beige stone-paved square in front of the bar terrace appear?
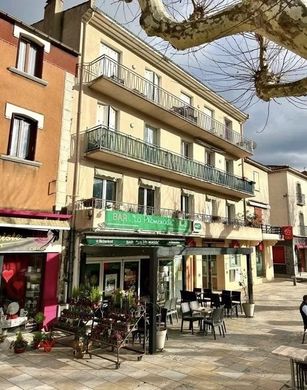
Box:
[0,279,307,390]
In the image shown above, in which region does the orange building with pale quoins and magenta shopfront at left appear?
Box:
[0,13,78,326]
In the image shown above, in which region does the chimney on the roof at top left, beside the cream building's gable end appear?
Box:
[43,0,64,41]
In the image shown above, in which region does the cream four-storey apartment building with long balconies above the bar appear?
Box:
[36,0,279,301]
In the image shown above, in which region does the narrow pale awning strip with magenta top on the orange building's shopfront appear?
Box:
[0,216,70,230]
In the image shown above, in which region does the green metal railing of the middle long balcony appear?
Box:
[85,126,254,195]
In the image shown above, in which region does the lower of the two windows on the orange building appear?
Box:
[8,114,37,160]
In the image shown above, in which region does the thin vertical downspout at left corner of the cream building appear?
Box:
[67,9,95,298]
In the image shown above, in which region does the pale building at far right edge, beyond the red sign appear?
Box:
[269,165,307,276]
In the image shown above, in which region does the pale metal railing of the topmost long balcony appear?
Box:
[83,55,255,153]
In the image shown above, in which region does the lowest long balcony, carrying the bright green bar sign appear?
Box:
[76,198,262,240]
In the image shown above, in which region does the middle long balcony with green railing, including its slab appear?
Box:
[85,126,254,199]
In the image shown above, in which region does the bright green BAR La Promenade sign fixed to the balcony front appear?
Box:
[105,210,191,234]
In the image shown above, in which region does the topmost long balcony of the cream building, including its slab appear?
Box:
[83,56,255,158]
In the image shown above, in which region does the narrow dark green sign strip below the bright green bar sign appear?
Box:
[84,237,185,247]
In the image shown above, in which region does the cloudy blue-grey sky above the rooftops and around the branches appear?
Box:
[0,0,307,170]
